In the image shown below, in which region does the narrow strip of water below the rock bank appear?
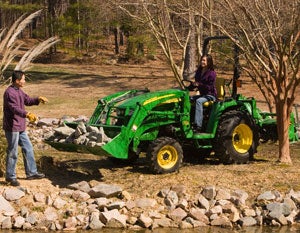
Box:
[0,227,300,233]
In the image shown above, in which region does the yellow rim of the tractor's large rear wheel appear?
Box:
[232,124,253,154]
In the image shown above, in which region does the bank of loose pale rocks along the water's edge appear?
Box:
[0,181,300,230]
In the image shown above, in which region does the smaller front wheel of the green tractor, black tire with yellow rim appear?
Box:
[147,137,183,174]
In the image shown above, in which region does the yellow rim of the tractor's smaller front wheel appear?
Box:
[157,145,178,169]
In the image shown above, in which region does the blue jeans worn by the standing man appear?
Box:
[5,131,37,179]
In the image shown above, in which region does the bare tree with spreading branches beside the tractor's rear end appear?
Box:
[209,0,300,163]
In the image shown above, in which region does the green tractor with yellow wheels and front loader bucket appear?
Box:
[49,37,299,173]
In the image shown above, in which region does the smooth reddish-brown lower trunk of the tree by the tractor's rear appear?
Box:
[276,100,292,164]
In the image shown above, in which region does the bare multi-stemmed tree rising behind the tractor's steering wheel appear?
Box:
[119,0,203,86]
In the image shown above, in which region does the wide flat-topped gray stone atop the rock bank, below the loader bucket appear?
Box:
[88,184,122,198]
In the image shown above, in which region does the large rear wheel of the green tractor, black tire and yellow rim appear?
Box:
[214,110,259,164]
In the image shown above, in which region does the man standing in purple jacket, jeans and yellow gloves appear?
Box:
[3,70,48,186]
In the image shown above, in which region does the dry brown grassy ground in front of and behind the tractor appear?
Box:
[0,59,300,204]
